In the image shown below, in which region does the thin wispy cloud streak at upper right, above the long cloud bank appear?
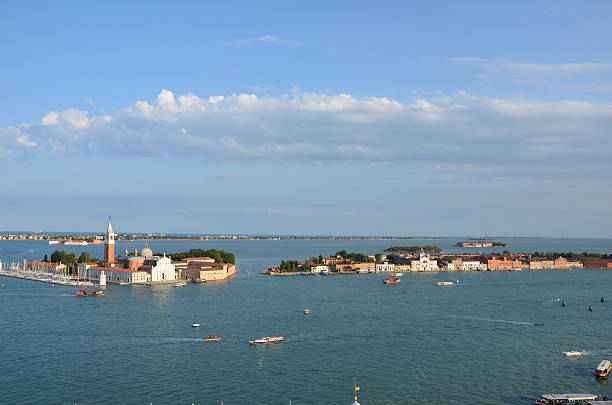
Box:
[449,56,612,74]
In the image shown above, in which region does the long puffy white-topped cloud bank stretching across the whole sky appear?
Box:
[0,89,612,179]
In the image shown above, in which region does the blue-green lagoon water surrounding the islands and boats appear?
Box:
[0,239,612,405]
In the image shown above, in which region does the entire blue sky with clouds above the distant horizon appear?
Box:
[0,0,612,237]
